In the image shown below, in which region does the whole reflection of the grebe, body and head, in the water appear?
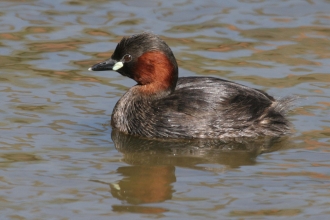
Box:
[105,130,283,213]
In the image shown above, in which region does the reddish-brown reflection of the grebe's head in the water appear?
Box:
[110,166,176,204]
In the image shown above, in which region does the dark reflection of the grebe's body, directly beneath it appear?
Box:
[111,130,283,169]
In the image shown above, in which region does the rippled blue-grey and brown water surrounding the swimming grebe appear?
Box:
[0,0,330,219]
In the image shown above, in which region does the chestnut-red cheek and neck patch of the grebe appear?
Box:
[133,51,178,95]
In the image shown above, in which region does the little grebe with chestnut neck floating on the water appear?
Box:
[89,33,292,138]
